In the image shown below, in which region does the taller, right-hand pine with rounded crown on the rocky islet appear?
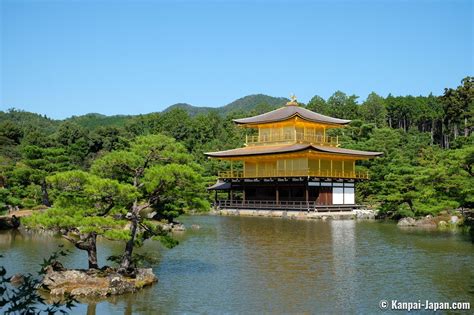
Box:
[92,135,209,272]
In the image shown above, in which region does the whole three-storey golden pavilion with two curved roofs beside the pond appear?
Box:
[205,96,383,210]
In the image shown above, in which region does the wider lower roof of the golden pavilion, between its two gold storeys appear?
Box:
[204,143,383,158]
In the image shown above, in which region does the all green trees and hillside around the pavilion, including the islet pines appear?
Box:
[0,77,474,308]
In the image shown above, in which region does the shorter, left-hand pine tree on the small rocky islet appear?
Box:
[25,171,138,268]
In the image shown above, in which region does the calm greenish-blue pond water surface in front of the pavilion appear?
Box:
[0,216,474,314]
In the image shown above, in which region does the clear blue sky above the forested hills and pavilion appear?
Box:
[0,0,474,118]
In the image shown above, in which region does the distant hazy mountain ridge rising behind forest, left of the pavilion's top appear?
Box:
[163,94,289,116]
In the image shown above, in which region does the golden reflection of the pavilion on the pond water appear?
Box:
[233,218,357,313]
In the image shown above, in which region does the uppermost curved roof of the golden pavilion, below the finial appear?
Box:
[233,102,351,125]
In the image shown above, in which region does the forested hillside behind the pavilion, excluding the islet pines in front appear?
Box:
[0,77,474,216]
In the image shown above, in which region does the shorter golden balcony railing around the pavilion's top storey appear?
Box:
[245,132,339,147]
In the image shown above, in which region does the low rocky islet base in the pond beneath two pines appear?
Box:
[42,268,158,297]
